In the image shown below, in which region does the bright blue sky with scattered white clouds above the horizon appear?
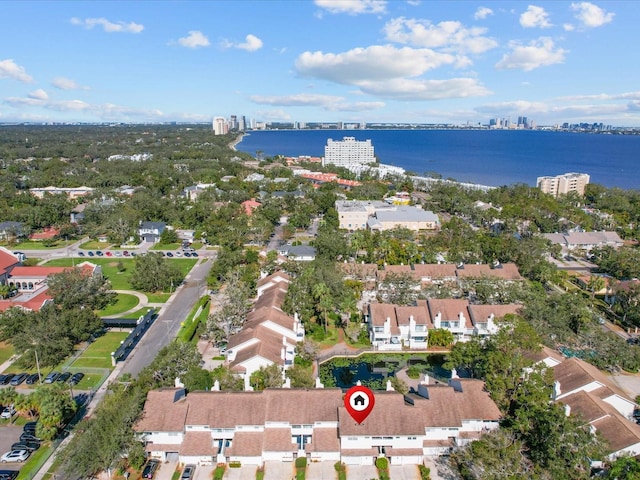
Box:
[0,0,640,127]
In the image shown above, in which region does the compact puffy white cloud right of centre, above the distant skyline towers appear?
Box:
[496,37,567,72]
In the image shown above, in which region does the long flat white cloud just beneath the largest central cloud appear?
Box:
[360,78,492,101]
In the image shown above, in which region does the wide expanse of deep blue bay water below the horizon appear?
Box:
[236,130,640,190]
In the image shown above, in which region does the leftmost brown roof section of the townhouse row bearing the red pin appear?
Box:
[134,388,189,432]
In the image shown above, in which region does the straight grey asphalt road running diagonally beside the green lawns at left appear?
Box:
[120,259,212,377]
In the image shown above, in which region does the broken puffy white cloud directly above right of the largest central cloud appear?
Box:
[383,17,498,54]
